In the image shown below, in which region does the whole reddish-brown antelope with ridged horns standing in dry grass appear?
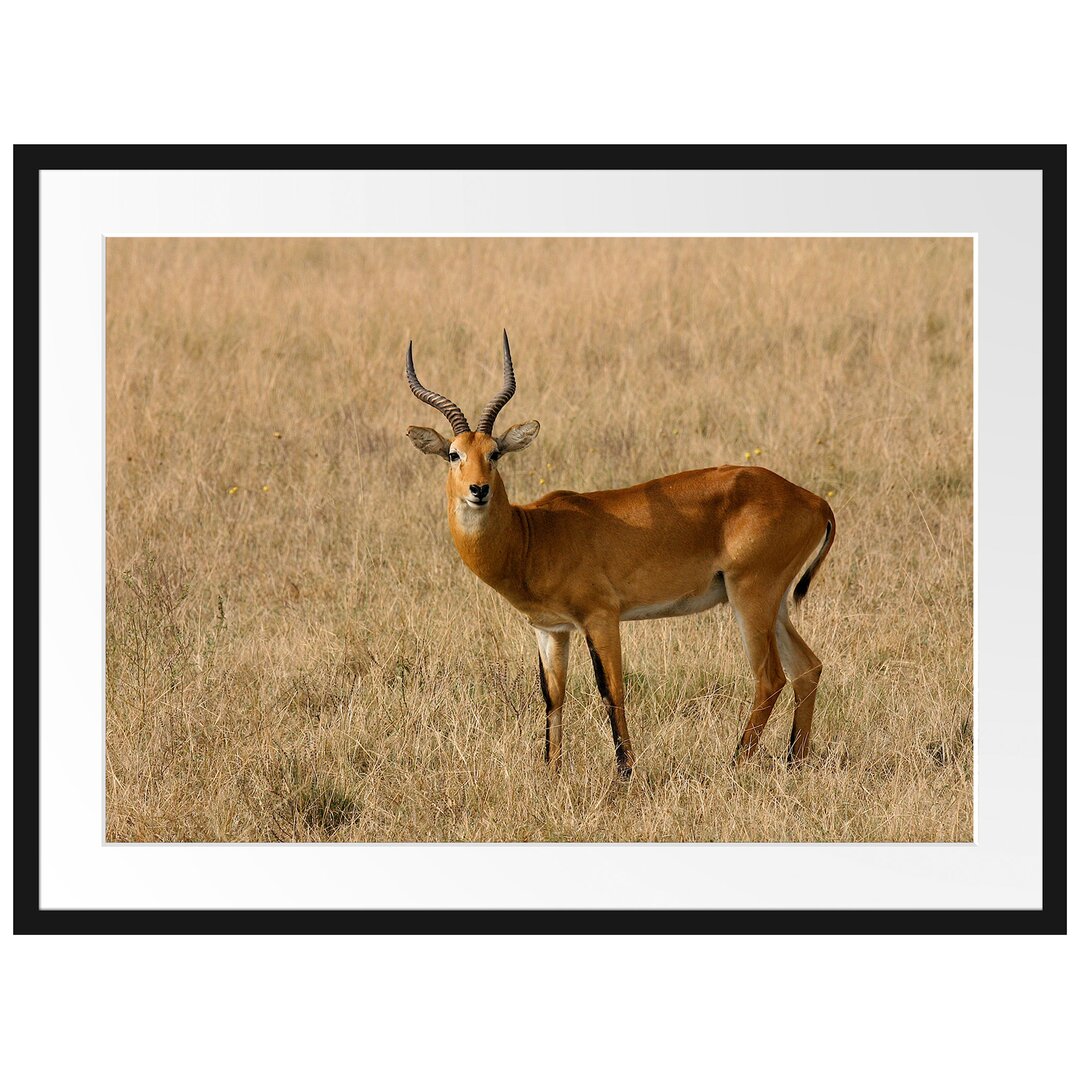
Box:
[405,330,836,780]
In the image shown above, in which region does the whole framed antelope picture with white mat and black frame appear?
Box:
[16,147,1064,933]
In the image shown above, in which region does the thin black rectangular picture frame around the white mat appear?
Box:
[13,145,1067,934]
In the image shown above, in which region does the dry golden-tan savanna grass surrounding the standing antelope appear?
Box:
[106,239,973,841]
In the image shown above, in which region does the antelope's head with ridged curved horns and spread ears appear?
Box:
[405,330,540,520]
